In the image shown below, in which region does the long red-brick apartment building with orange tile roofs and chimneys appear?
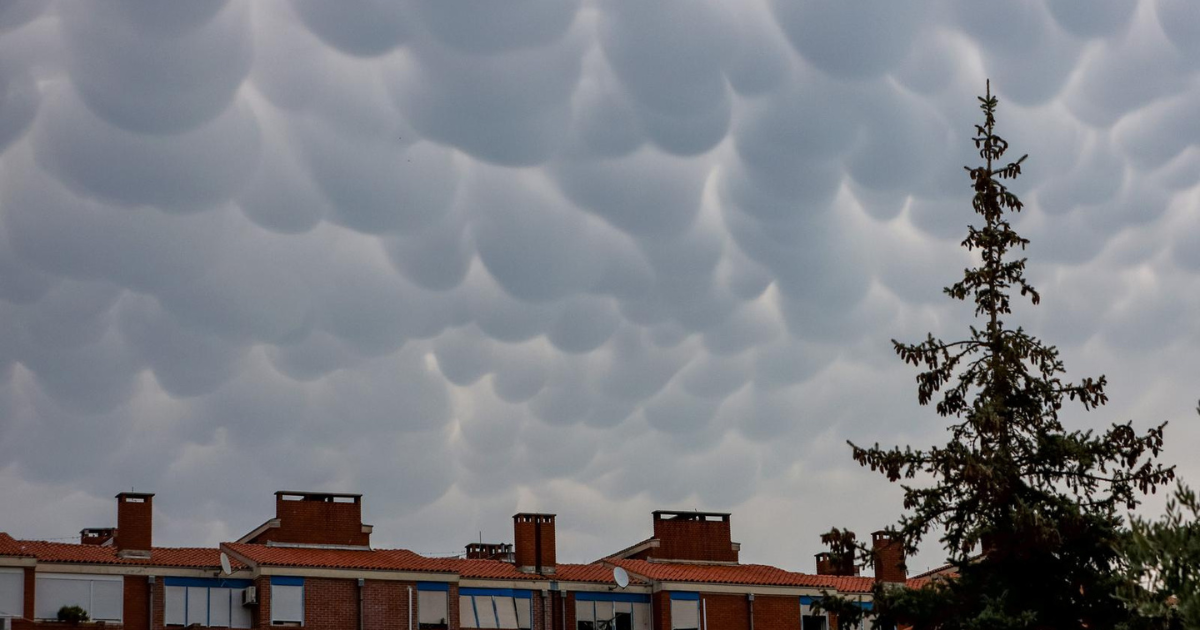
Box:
[0,492,923,630]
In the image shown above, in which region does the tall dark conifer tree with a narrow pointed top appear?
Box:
[828,85,1175,630]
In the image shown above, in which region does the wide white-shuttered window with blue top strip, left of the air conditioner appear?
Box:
[163,577,252,628]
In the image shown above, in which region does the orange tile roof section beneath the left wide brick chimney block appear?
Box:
[222,542,451,572]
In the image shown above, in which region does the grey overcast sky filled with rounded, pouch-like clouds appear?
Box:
[0,0,1200,571]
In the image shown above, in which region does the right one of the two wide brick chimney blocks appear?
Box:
[650,510,740,563]
